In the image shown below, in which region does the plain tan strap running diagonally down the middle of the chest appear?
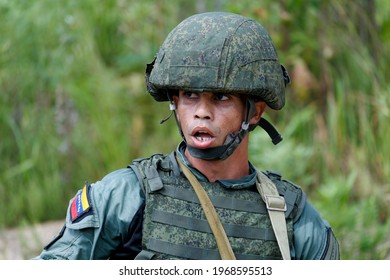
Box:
[176,157,236,260]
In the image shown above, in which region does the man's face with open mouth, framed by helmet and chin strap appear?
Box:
[173,91,245,149]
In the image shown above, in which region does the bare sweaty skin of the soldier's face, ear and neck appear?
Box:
[173,91,266,182]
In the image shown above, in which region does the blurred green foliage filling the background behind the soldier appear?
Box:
[0,0,390,259]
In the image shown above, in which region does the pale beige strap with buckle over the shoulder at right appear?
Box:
[256,171,291,260]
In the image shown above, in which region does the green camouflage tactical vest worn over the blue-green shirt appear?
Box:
[130,153,305,260]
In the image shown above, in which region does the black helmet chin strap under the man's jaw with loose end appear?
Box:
[161,94,283,161]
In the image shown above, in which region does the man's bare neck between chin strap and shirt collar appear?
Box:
[185,137,249,182]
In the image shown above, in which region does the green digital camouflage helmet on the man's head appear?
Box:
[145,12,289,110]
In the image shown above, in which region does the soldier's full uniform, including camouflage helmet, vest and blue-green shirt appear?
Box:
[37,12,339,259]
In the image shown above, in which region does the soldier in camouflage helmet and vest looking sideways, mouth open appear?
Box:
[36,12,340,259]
